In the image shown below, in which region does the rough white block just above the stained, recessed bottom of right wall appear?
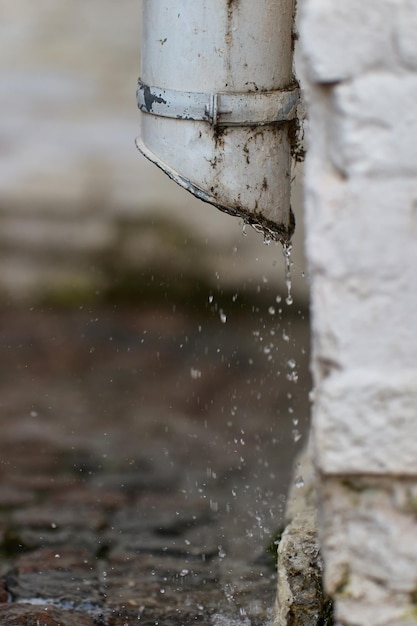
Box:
[313,363,417,472]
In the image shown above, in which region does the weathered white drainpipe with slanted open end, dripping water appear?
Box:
[137,0,298,241]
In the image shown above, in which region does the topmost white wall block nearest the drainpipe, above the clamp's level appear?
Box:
[300,0,398,83]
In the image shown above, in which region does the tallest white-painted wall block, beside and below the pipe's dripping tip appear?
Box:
[306,173,417,373]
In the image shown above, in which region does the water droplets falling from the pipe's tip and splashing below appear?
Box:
[185,235,305,626]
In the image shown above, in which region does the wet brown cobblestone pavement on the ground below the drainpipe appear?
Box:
[0,304,309,626]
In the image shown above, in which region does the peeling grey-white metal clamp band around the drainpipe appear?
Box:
[137,79,299,126]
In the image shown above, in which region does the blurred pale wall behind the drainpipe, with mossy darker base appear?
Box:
[0,0,307,300]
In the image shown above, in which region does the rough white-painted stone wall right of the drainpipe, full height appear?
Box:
[300,0,417,626]
